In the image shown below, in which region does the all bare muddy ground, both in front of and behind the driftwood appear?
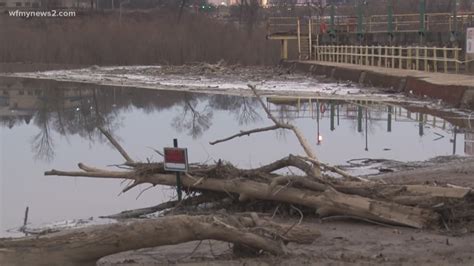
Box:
[98,157,474,265]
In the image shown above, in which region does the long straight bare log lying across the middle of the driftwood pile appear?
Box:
[45,167,438,228]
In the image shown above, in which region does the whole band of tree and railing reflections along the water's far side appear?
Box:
[0,79,473,160]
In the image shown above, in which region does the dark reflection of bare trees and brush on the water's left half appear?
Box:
[0,81,261,160]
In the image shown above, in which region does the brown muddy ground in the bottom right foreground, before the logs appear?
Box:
[98,219,474,265]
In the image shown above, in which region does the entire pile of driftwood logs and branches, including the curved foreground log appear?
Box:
[0,86,472,265]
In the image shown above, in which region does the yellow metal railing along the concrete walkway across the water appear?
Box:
[312,45,462,73]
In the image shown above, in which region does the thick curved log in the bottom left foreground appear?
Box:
[0,215,319,266]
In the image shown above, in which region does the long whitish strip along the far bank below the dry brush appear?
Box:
[9,66,361,95]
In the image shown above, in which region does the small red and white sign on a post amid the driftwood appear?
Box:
[164,139,188,201]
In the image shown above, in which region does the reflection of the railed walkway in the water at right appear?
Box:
[267,97,474,155]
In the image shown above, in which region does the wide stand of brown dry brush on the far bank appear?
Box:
[0,11,279,65]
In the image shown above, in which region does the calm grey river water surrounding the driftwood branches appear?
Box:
[0,78,474,236]
